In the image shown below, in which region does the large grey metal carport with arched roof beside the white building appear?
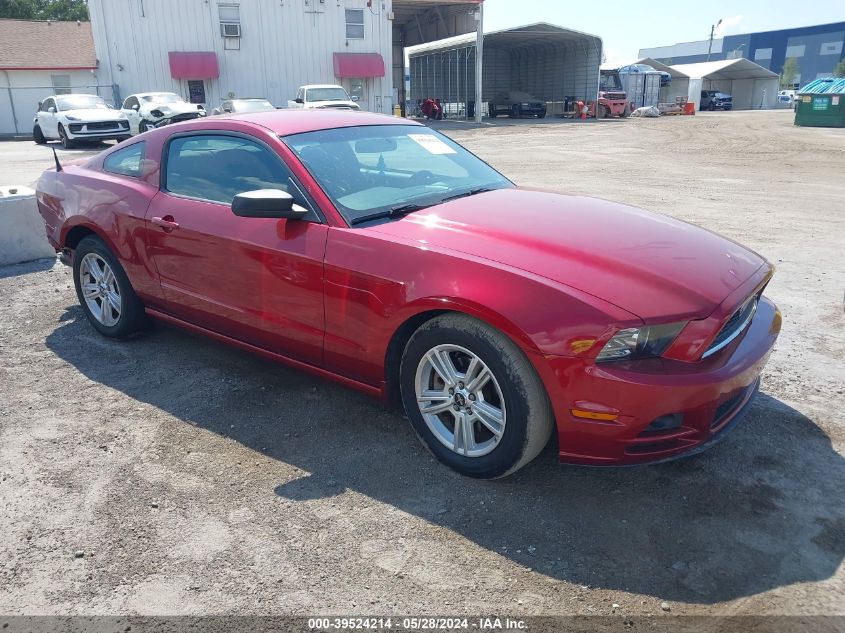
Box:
[408,22,602,117]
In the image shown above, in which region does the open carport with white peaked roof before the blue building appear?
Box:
[671,57,779,110]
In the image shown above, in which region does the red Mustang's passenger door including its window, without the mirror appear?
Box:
[147,132,327,364]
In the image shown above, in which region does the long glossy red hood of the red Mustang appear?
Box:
[368,189,765,321]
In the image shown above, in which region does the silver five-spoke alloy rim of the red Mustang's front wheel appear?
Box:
[414,344,506,457]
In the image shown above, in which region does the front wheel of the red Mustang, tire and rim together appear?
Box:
[400,314,554,479]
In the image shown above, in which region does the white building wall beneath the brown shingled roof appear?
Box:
[0,70,113,135]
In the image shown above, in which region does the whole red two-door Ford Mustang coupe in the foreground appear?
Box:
[38,111,780,478]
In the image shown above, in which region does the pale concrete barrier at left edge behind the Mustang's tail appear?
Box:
[0,187,56,266]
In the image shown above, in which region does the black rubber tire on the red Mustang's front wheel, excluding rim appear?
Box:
[400,314,554,479]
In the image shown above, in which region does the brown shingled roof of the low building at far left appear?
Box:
[0,20,97,70]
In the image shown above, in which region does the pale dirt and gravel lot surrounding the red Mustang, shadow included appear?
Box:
[0,111,845,615]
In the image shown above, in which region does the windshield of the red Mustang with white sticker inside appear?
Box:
[283,125,513,224]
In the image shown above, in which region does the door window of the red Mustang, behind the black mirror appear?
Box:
[165,134,317,214]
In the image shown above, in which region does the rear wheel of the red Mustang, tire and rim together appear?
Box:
[73,236,146,339]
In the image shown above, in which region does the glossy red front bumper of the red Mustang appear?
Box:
[546,297,781,465]
